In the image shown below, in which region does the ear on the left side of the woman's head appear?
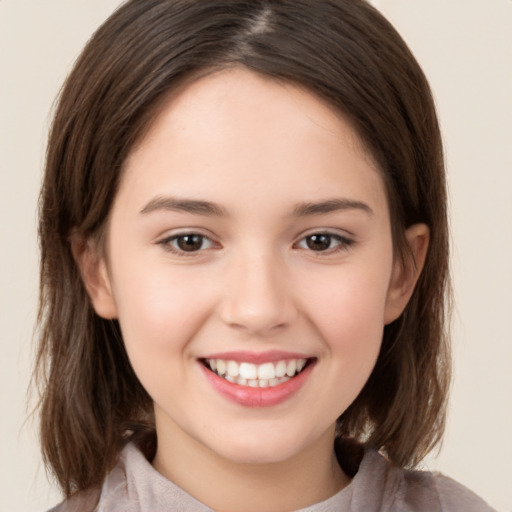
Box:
[71,235,117,320]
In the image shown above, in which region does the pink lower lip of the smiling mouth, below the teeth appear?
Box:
[199,363,314,407]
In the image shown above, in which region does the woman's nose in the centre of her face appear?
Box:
[220,248,298,337]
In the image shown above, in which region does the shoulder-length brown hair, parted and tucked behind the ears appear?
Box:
[36,0,449,496]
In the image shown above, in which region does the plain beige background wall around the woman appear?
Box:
[0,0,512,512]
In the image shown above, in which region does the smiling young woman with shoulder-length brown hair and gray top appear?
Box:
[38,0,490,512]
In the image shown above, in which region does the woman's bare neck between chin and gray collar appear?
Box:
[153,422,350,512]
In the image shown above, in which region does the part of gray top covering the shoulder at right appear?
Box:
[353,450,494,512]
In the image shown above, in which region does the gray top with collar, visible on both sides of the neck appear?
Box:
[49,444,493,512]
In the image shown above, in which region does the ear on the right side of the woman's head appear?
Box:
[384,224,430,325]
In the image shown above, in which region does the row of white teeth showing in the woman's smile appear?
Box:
[206,359,307,388]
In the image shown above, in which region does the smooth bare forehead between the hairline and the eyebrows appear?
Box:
[121,68,383,218]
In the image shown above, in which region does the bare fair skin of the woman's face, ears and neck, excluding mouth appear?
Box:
[76,69,428,512]
